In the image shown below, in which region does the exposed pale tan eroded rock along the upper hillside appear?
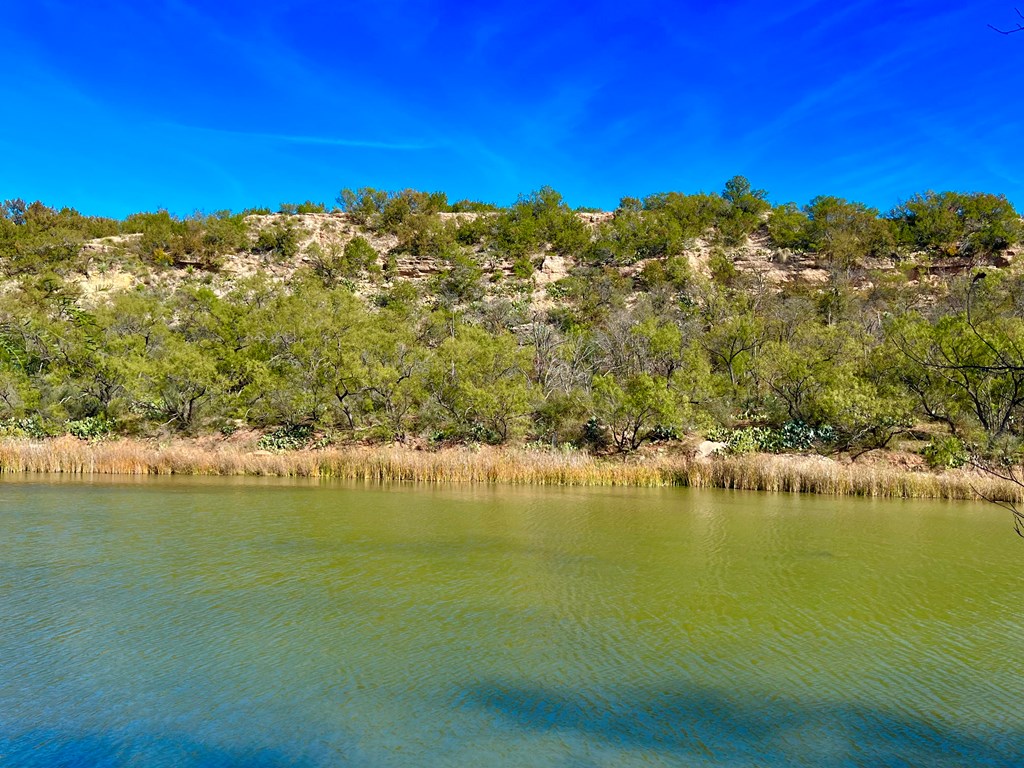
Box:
[72,212,1020,310]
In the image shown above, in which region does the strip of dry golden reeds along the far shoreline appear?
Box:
[0,437,1022,502]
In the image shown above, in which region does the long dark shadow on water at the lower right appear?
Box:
[460,682,1024,768]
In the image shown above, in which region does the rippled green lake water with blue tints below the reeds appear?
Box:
[0,478,1024,768]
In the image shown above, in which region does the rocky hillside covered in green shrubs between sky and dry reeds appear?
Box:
[0,186,1024,473]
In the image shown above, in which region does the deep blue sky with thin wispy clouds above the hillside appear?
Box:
[0,0,1024,217]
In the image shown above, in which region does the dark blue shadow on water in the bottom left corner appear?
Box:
[0,729,352,768]
